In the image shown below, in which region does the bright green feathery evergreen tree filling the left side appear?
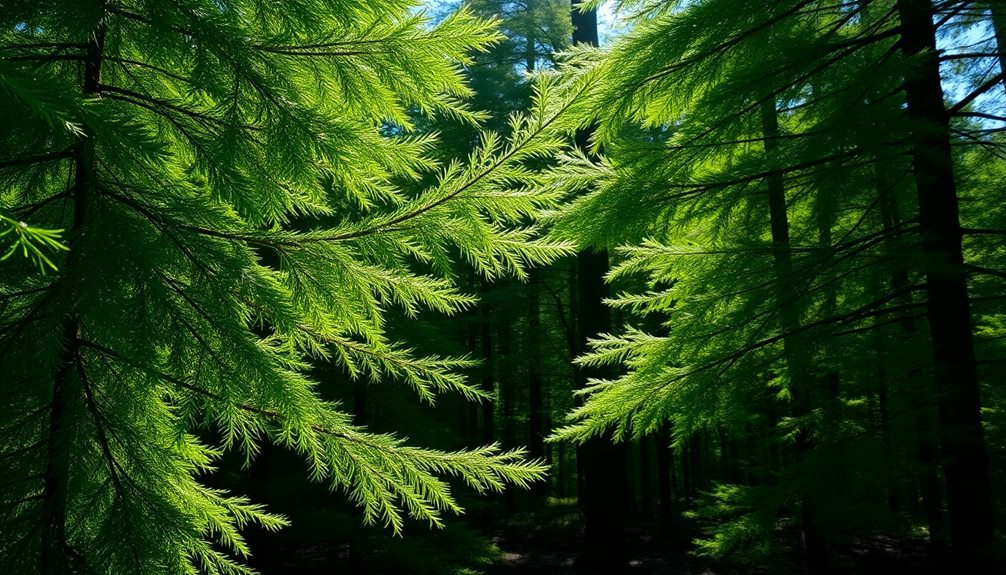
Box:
[0,0,569,574]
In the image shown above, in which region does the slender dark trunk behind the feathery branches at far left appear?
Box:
[38,12,106,575]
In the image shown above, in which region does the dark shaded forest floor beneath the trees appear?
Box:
[258,503,933,575]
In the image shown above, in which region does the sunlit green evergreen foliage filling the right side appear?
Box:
[553,0,1003,572]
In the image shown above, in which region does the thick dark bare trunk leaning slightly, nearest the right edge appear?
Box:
[897,0,995,572]
